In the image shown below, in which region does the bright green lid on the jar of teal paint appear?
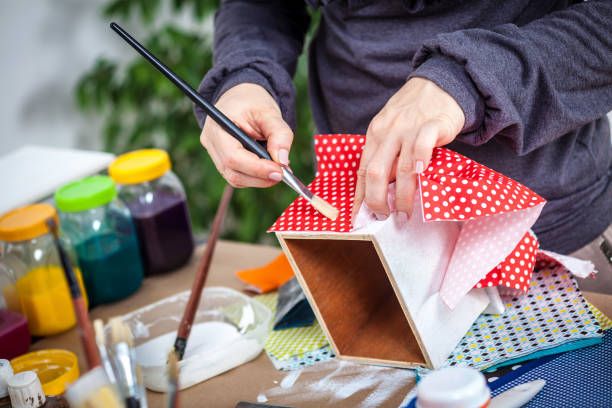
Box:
[55,176,117,212]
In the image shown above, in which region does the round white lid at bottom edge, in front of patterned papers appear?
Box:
[416,367,491,408]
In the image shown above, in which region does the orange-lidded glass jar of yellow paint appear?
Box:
[0,204,87,336]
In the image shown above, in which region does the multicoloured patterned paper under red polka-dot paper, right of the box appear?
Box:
[448,267,602,370]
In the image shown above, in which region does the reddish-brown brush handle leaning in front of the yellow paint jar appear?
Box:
[47,218,100,370]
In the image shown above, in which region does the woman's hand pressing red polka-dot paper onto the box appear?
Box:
[353,78,465,219]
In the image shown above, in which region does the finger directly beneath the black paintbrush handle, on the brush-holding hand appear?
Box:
[212,132,282,181]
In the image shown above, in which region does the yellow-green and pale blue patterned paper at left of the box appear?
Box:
[256,293,334,370]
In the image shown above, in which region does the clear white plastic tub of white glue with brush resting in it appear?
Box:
[110,287,272,392]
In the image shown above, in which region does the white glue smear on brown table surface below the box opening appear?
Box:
[260,359,414,407]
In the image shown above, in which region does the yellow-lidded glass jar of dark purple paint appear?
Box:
[108,149,194,275]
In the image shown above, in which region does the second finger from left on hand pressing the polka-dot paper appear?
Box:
[364,137,400,218]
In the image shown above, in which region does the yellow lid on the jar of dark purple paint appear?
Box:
[108,149,172,184]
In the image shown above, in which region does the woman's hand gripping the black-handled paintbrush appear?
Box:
[200,84,293,187]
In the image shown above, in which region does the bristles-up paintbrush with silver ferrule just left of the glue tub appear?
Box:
[109,317,140,408]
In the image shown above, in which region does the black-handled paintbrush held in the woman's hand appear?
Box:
[110,23,338,220]
